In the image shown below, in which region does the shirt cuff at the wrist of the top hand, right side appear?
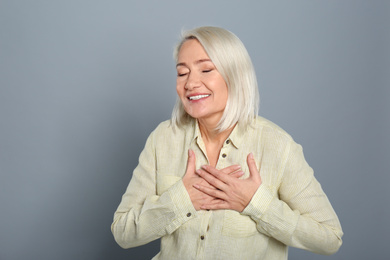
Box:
[241,184,274,219]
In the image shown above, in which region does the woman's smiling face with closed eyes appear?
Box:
[176,39,228,123]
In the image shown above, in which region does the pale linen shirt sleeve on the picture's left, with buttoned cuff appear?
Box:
[111,132,197,248]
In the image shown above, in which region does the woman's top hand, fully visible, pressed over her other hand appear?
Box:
[194,153,261,212]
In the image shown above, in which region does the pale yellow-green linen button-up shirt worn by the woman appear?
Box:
[111,117,343,260]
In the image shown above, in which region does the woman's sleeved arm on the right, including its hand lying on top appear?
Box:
[195,141,343,254]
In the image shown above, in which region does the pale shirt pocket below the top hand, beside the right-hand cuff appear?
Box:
[222,210,258,237]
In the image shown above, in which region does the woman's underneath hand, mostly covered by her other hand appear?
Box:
[183,150,244,210]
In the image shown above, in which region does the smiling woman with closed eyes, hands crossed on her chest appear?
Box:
[111,27,343,260]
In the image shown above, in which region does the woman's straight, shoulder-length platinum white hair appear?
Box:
[171,26,259,132]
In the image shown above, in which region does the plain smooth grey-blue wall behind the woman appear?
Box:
[0,0,390,260]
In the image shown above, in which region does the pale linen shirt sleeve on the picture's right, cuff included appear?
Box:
[242,141,343,254]
